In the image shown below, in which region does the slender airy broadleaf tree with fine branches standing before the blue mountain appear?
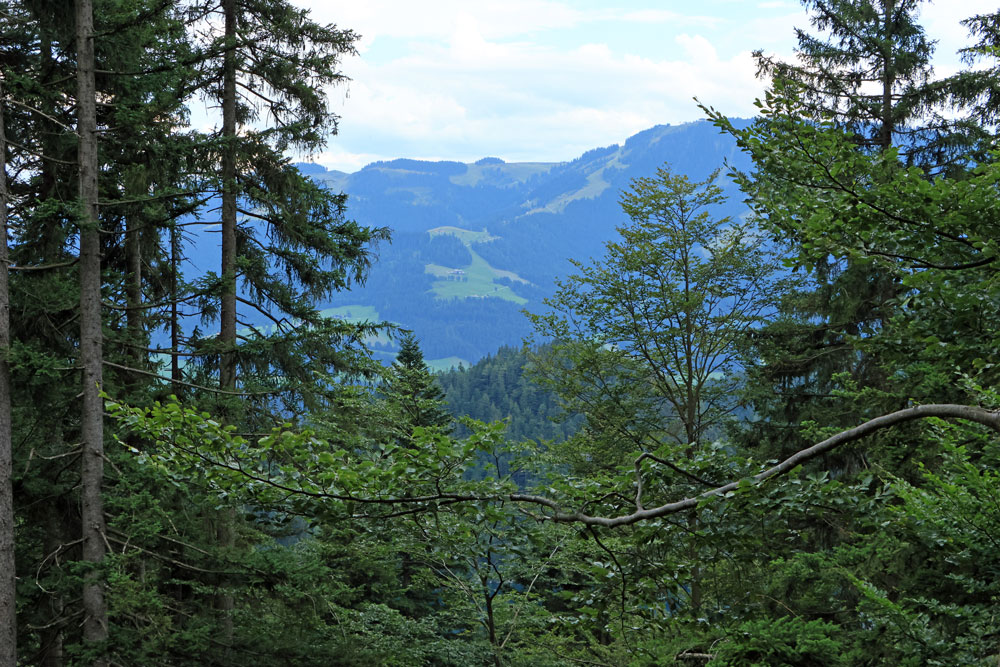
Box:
[531,167,785,465]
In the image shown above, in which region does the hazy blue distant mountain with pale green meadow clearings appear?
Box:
[304,121,748,367]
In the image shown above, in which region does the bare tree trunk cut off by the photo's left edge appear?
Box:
[0,72,17,665]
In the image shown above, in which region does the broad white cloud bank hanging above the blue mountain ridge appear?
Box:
[325,22,761,169]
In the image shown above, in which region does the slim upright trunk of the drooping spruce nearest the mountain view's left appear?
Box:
[219,0,237,389]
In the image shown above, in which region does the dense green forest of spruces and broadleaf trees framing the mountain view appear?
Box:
[0,0,1000,667]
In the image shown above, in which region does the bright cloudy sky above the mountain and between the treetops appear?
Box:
[293,0,998,172]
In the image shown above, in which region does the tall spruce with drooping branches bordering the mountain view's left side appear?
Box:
[188,0,385,402]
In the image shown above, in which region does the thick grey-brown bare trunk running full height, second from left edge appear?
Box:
[76,0,108,665]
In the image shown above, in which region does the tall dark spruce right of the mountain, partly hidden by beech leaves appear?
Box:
[728,0,955,460]
